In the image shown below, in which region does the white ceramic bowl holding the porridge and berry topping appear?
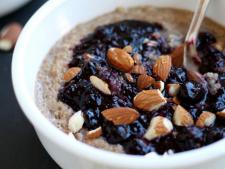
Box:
[12,0,225,169]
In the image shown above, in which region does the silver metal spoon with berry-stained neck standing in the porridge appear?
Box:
[183,0,210,72]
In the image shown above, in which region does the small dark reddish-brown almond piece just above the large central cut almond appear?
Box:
[137,74,155,89]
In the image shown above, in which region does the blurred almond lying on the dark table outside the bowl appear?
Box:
[0,22,22,51]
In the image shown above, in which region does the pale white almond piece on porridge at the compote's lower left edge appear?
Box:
[68,111,84,133]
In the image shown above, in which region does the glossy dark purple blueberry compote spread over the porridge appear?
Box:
[58,20,225,155]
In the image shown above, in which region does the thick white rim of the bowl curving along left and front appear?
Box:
[11,0,225,168]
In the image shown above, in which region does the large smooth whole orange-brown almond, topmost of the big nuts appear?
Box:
[107,48,134,73]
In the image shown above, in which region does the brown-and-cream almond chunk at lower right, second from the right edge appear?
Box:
[196,111,216,127]
